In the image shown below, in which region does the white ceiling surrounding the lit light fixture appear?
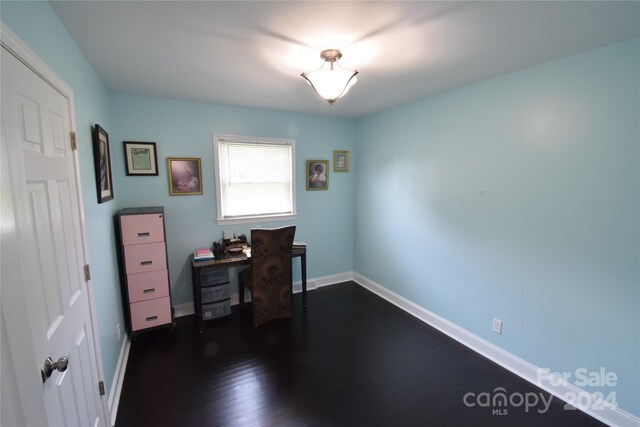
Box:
[52,1,640,117]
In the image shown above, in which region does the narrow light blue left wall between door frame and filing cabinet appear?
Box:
[0,1,124,389]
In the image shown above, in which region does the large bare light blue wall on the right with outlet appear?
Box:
[354,39,640,416]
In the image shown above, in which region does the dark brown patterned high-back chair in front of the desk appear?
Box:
[238,226,296,326]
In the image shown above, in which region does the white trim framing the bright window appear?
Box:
[213,134,298,225]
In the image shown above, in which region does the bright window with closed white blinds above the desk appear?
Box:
[213,136,296,224]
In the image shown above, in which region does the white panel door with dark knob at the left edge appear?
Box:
[1,41,106,426]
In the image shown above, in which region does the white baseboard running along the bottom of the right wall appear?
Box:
[352,273,640,427]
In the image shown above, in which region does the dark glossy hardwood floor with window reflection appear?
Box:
[116,282,602,427]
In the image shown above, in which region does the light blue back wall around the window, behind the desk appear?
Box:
[110,95,355,305]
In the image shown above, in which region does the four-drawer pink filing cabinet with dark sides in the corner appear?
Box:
[116,207,175,336]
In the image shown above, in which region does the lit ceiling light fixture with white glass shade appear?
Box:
[301,49,358,105]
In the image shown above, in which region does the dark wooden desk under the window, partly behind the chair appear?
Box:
[191,247,307,332]
